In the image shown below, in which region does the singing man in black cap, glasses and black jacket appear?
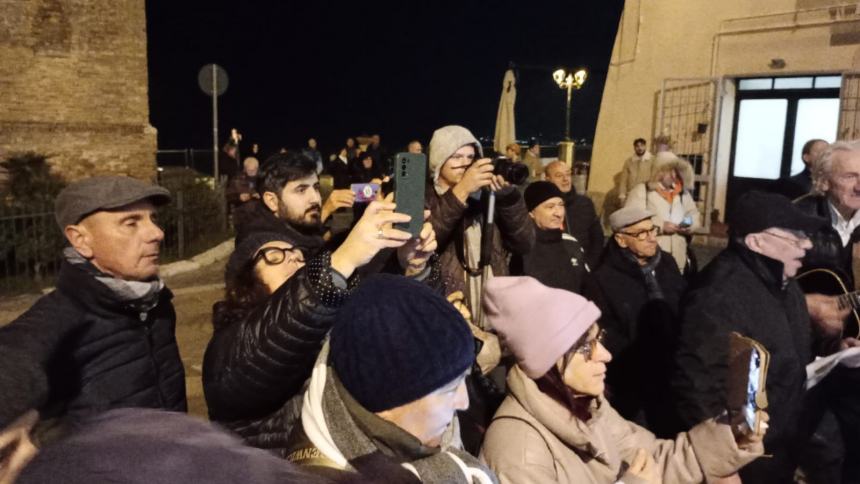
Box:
[672,192,839,483]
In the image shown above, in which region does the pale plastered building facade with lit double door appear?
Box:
[589,0,860,227]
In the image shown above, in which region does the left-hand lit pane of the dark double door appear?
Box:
[734,99,788,180]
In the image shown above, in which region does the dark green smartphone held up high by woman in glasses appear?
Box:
[394,153,427,237]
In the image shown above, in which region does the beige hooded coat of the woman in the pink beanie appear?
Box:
[481,366,763,484]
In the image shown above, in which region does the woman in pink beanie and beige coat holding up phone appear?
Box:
[481,277,766,484]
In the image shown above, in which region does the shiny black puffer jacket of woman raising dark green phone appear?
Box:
[203,252,348,450]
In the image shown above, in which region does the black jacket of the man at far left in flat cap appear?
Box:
[0,263,186,428]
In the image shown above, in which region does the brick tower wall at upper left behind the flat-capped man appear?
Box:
[0,0,156,180]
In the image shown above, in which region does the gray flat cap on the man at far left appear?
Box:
[54,176,170,230]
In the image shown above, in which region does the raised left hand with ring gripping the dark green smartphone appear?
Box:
[331,193,412,277]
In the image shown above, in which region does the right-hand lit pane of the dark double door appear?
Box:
[791,98,839,175]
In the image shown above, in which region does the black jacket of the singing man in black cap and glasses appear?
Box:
[672,241,812,454]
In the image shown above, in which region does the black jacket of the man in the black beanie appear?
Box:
[511,221,589,293]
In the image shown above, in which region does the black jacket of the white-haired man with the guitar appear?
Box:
[794,195,860,287]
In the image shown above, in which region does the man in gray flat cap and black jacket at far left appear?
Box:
[0,176,186,455]
